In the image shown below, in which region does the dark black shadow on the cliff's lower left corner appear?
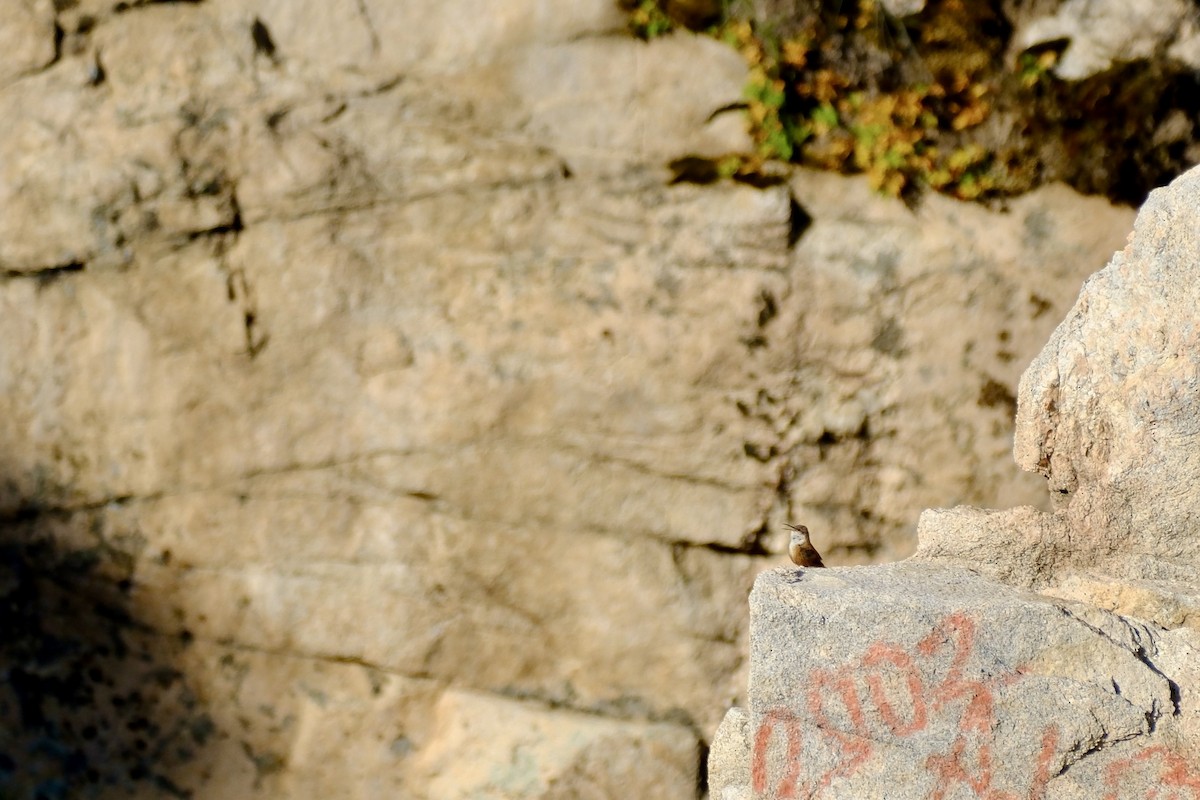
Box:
[0,484,216,800]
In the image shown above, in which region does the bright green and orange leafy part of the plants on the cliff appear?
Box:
[714,0,1027,200]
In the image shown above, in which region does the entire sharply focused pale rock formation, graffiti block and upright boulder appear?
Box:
[709,169,1200,800]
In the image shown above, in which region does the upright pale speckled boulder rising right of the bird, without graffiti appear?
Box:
[1015,165,1200,564]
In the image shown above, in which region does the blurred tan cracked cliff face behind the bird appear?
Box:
[0,0,1130,798]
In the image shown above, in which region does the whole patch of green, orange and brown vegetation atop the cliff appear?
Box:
[626,0,1200,208]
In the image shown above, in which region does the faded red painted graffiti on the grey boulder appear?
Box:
[751,613,1200,800]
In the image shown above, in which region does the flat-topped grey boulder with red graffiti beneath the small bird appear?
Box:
[729,563,1200,798]
